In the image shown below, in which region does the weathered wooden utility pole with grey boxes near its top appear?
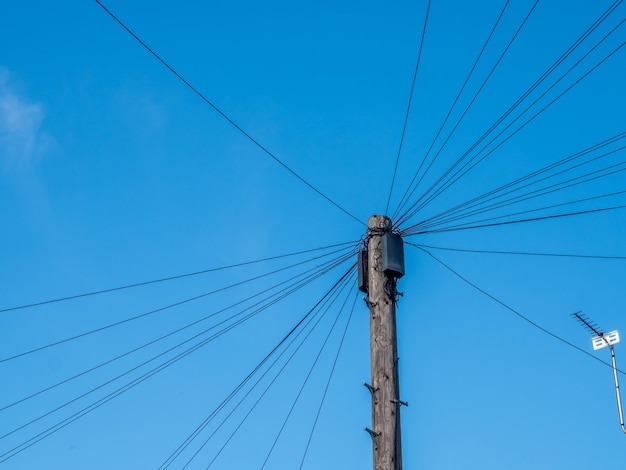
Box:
[361,215,406,470]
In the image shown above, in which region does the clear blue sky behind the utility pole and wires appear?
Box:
[0,0,626,470]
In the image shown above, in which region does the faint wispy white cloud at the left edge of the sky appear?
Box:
[0,68,51,168]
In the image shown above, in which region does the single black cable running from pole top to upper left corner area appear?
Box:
[95,0,367,226]
